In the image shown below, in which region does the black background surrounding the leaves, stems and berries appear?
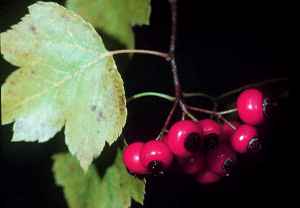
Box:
[0,0,290,208]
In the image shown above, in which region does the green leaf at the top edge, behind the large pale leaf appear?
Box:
[66,0,151,48]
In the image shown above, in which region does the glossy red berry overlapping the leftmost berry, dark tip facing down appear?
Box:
[141,140,173,173]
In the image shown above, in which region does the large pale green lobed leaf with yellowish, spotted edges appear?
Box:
[0,2,127,169]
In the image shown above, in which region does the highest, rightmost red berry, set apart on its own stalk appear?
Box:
[237,89,270,125]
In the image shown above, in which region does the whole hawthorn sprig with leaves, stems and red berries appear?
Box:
[1,0,287,208]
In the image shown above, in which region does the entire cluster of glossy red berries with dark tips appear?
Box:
[123,89,271,184]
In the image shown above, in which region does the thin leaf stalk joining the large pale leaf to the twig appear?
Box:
[103,49,170,60]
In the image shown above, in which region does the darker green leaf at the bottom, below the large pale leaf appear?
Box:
[53,150,145,208]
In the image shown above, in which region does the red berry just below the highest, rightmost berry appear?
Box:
[231,124,261,153]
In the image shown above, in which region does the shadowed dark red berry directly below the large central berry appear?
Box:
[178,154,205,174]
